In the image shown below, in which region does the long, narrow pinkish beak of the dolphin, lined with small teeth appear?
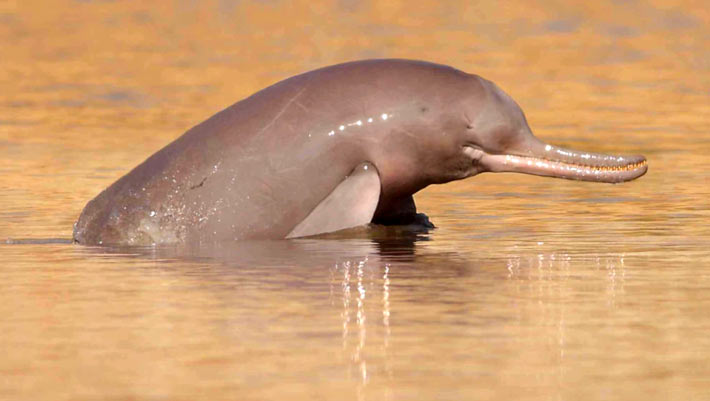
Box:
[479,145,648,183]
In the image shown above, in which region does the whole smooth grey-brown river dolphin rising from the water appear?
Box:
[74,60,647,245]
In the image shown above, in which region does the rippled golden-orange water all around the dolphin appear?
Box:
[0,0,710,400]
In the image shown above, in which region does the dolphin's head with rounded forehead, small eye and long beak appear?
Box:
[447,75,647,183]
